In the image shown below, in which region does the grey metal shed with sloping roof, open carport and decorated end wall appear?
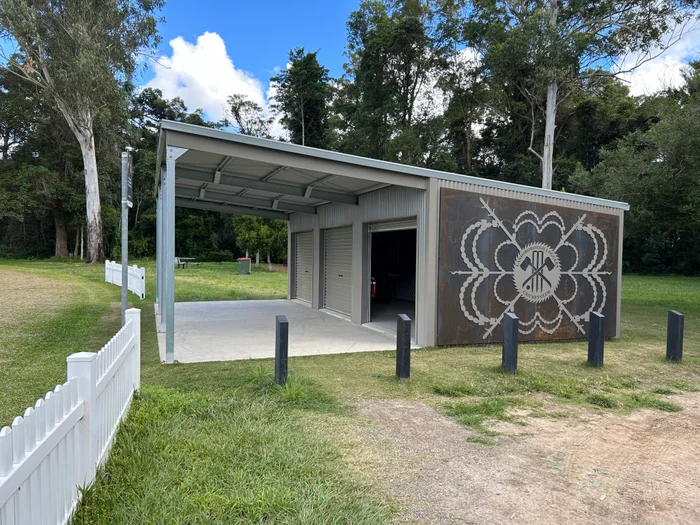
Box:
[156,121,629,362]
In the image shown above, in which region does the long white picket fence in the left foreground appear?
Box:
[0,308,141,525]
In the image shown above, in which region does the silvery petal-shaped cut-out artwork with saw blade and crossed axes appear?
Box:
[443,188,617,342]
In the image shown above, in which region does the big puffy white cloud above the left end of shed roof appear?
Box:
[147,32,268,120]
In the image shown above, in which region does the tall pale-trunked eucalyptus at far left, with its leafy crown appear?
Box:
[0,0,163,262]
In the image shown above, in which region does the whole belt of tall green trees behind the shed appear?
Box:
[0,0,700,274]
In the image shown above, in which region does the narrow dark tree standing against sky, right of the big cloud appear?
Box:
[270,47,332,149]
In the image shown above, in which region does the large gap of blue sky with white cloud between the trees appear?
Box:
[140,0,360,125]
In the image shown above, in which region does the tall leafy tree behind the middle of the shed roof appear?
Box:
[335,0,449,163]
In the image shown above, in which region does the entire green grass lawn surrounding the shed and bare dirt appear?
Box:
[0,261,700,524]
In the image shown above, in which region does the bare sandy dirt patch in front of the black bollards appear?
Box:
[354,394,700,525]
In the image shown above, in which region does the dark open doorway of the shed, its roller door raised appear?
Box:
[369,228,416,340]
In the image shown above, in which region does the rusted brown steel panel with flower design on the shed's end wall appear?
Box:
[438,188,620,345]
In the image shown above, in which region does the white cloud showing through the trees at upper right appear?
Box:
[620,29,700,96]
